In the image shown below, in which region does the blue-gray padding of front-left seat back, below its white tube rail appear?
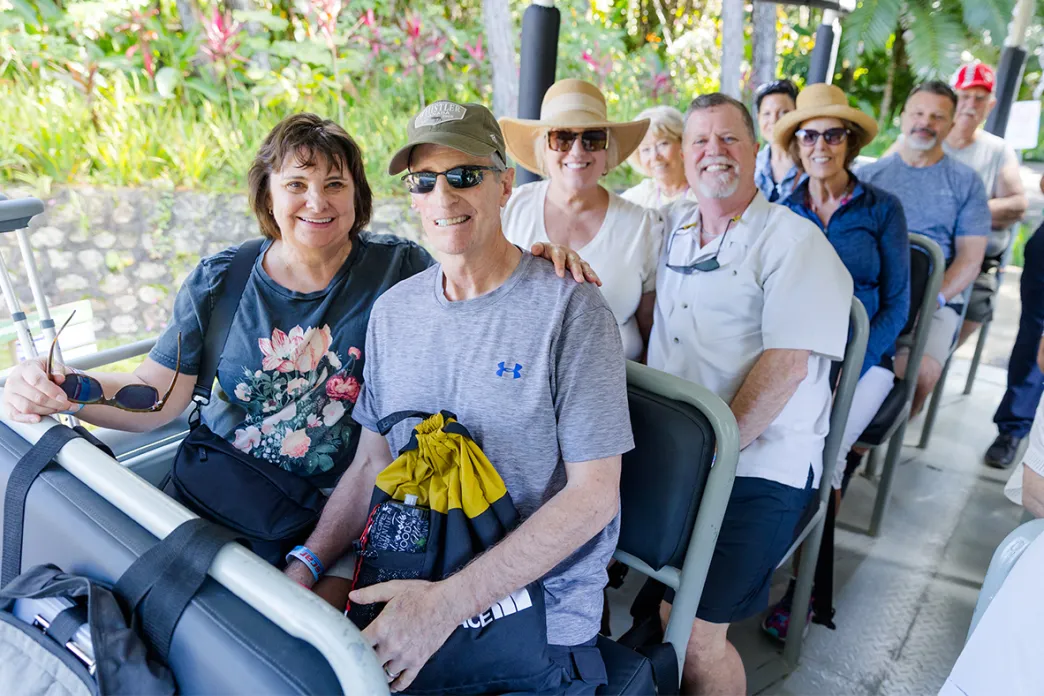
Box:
[0,424,340,694]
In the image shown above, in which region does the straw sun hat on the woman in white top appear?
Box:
[500,79,649,174]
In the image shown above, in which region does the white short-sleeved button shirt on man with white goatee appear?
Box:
[648,193,852,487]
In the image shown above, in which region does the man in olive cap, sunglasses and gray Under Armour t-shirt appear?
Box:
[309,101,634,694]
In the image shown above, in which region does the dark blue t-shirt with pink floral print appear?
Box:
[150,234,432,487]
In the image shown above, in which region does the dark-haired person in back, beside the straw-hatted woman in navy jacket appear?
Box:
[754,79,801,202]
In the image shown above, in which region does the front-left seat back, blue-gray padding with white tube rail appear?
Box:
[0,423,384,694]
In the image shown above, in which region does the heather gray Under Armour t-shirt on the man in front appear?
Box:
[352,253,634,645]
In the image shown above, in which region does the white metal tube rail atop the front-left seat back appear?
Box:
[2,417,388,694]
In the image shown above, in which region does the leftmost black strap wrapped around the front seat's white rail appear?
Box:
[0,425,79,586]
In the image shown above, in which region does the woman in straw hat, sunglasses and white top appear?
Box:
[500,79,663,359]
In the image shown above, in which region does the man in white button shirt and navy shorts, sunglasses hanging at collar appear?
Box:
[648,94,852,694]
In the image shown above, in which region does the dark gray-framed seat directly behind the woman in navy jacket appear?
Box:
[856,234,946,536]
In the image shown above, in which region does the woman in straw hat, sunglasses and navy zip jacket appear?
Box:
[762,85,910,639]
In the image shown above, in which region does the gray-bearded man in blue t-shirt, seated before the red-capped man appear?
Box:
[858,80,992,415]
